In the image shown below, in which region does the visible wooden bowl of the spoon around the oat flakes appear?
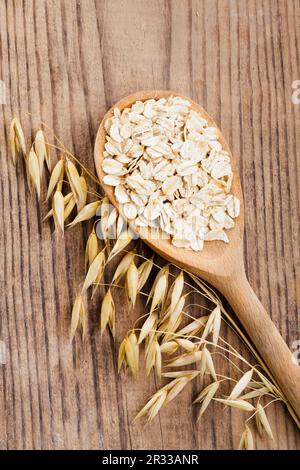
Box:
[95,91,244,284]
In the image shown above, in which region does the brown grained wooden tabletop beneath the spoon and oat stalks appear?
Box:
[0,0,300,449]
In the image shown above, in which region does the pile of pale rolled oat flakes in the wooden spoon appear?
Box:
[102,96,240,251]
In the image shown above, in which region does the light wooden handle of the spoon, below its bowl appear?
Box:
[220,273,300,419]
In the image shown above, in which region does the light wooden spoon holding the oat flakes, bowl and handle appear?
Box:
[95,90,300,418]
